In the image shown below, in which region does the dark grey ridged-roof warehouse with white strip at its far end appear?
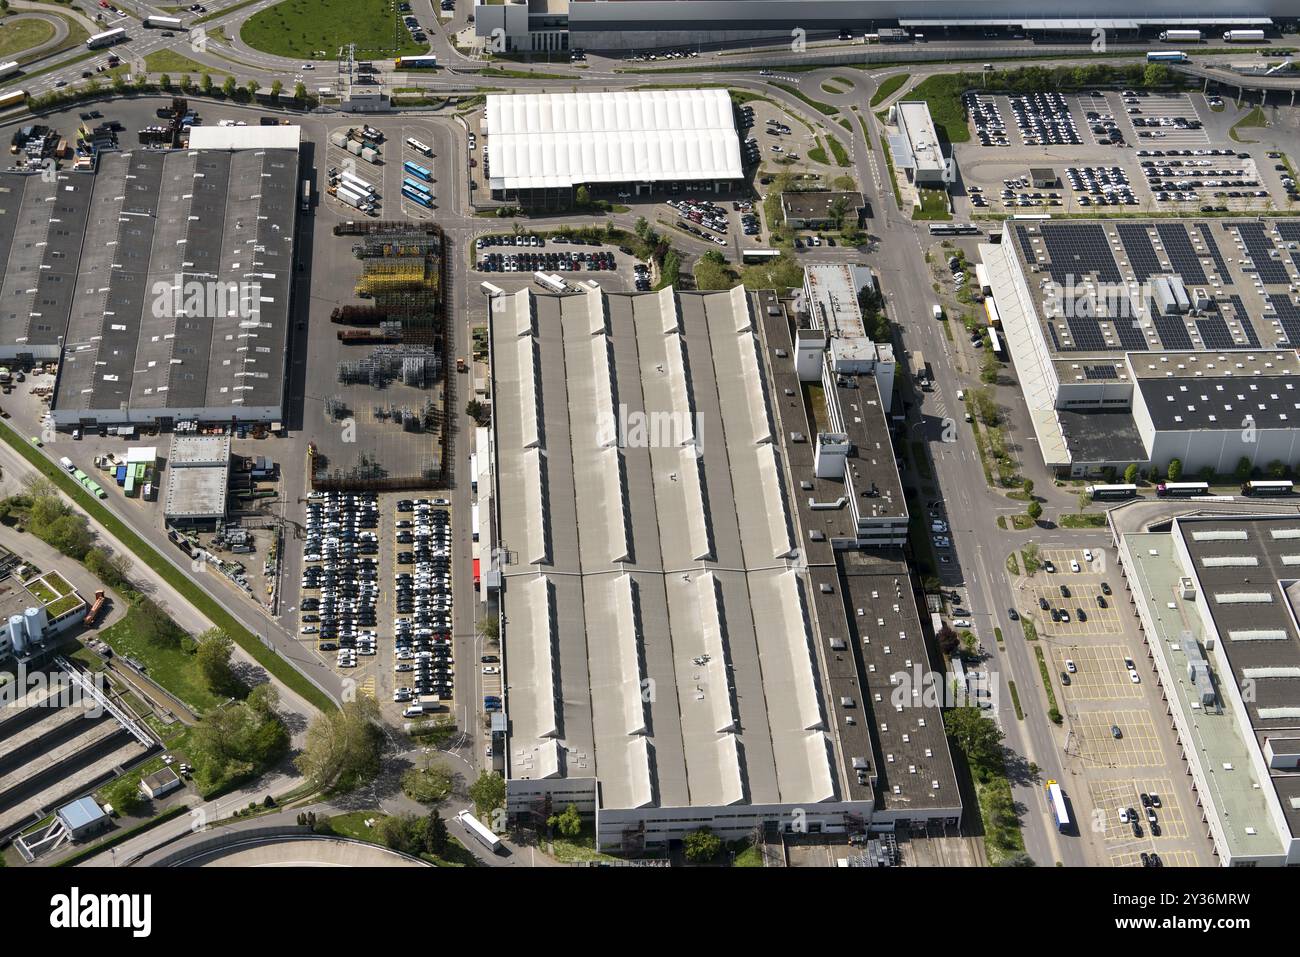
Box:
[38,126,299,428]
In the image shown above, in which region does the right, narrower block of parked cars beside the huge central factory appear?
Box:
[393,498,455,718]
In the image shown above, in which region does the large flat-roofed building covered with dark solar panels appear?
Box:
[980,220,1300,477]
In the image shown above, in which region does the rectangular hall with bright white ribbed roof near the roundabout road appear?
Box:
[486,90,742,205]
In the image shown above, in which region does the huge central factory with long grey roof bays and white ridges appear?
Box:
[491,280,961,850]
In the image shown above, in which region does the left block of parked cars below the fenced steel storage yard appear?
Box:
[299,492,380,668]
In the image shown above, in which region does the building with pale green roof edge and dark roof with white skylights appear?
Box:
[1112,503,1300,867]
